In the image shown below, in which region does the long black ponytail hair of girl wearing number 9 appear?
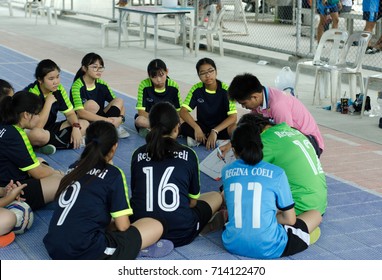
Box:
[55,121,118,198]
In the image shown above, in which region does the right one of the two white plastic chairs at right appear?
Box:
[314,32,372,111]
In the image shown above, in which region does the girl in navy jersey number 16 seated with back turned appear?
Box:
[131,102,224,247]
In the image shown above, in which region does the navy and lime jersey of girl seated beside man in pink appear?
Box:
[182,80,237,129]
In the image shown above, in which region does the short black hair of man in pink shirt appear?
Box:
[228,73,264,101]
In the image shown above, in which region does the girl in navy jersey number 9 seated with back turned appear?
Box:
[44,121,174,259]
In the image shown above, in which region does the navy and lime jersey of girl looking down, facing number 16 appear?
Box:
[135,78,182,113]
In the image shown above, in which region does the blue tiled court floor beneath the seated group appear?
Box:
[0,45,382,260]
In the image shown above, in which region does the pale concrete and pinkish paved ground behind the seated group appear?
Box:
[0,7,382,193]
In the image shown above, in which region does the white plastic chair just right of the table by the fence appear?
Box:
[194,7,225,56]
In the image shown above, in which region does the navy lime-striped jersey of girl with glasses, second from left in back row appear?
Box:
[70,77,116,111]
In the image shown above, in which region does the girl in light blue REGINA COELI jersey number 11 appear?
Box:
[222,124,321,259]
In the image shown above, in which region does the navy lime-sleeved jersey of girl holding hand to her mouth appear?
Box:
[25,81,73,130]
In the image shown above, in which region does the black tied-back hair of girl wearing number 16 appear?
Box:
[146,102,181,161]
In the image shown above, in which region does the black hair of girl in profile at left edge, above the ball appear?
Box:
[0,90,42,125]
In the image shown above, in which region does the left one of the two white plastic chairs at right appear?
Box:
[294,29,348,104]
